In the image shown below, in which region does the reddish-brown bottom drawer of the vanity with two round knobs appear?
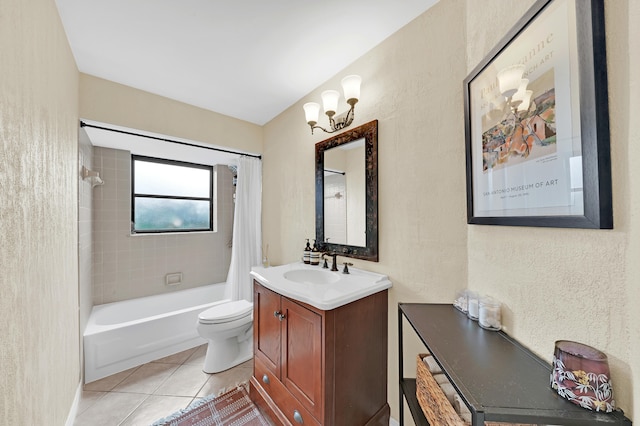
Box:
[253,358,320,426]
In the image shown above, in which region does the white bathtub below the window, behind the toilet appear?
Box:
[83,283,225,383]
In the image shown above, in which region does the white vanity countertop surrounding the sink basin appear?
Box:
[251,262,392,311]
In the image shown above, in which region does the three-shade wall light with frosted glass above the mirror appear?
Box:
[302,75,362,134]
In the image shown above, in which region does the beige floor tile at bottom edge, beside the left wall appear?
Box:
[74,392,148,426]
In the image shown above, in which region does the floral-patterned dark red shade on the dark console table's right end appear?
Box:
[551,340,615,413]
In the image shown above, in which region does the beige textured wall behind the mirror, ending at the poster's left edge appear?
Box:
[263,0,467,418]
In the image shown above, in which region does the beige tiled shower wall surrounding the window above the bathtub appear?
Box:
[91,147,235,305]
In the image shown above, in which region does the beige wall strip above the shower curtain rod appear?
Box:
[80,73,262,154]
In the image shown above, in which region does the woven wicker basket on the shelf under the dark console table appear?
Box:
[416,354,532,426]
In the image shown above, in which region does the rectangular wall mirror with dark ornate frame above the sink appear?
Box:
[316,120,378,262]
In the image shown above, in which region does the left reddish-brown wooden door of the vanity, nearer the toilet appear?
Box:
[253,283,284,377]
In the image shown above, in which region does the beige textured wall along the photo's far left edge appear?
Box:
[0,0,80,425]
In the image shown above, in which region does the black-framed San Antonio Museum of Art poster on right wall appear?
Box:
[464,0,613,229]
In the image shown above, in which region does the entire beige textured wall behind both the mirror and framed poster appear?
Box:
[263,0,640,420]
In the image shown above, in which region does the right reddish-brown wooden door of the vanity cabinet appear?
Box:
[281,297,324,423]
